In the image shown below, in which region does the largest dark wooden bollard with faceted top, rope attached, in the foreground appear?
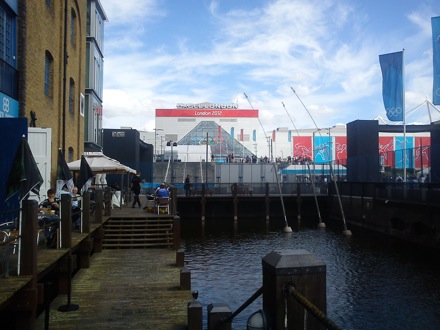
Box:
[262,250,326,329]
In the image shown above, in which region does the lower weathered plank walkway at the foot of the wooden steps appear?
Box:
[37,249,192,330]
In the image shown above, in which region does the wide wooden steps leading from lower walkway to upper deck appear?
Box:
[102,216,173,249]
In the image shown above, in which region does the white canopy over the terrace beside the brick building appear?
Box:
[67,152,136,174]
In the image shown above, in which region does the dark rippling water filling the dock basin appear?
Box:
[183,222,440,329]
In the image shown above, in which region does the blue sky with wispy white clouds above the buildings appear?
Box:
[100,0,440,131]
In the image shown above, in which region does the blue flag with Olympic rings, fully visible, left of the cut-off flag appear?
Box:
[379,51,404,121]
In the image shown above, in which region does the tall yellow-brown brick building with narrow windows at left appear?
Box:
[17,0,87,170]
